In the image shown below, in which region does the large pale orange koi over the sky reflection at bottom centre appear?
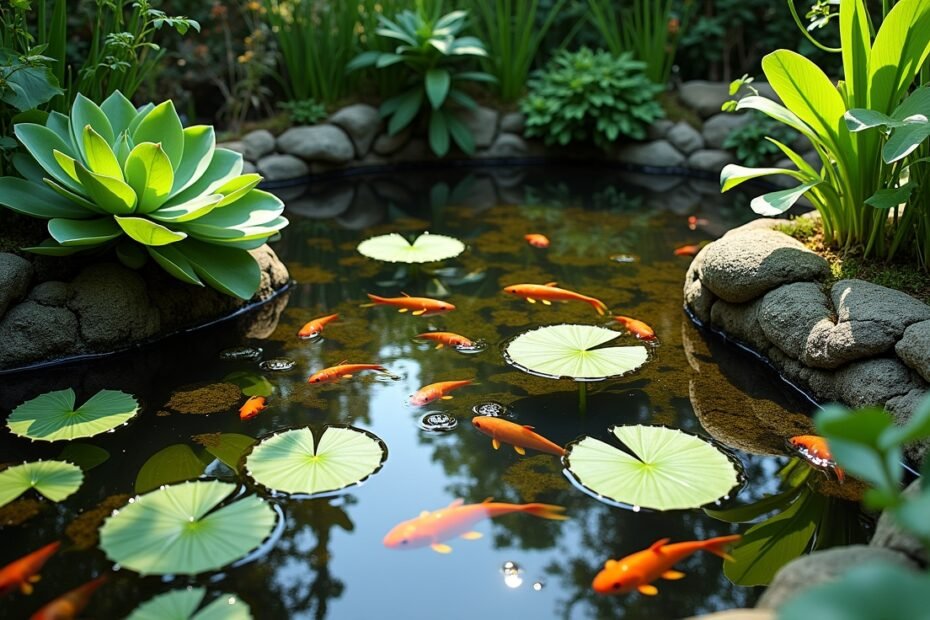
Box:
[384,498,568,553]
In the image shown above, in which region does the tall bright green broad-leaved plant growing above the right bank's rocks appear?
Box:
[720,0,930,265]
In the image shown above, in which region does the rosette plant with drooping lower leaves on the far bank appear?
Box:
[346,8,495,157]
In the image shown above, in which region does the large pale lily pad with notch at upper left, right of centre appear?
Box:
[565,425,739,510]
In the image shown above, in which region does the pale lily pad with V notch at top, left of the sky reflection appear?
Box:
[245,426,387,495]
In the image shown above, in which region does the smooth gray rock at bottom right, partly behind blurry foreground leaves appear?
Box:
[756,545,917,609]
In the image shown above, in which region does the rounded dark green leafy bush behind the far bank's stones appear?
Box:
[520,47,664,148]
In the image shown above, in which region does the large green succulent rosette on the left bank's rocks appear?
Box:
[0,92,288,299]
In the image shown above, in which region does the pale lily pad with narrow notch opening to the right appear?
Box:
[504,324,649,381]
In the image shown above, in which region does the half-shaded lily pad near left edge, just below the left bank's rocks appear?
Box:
[6,388,139,441]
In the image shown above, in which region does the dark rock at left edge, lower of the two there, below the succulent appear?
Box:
[0,301,81,368]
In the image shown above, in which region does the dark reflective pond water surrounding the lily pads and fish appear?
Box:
[0,168,860,619]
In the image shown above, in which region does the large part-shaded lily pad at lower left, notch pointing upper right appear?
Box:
[100,480,275,575]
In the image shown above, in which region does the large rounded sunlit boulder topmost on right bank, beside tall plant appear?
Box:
[701,229,830,303]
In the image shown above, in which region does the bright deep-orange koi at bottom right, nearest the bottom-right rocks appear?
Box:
[591,534,740,596]
